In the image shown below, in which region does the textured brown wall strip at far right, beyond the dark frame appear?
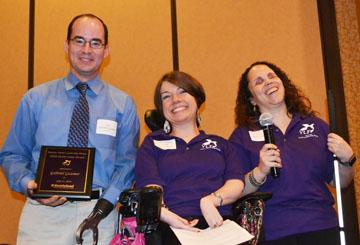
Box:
[335,0,360,233]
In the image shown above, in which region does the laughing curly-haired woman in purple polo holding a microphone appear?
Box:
[230,61,355,245]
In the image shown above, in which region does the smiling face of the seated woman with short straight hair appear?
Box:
[160,81,198,126]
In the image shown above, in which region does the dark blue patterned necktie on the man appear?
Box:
[67,83,89,147]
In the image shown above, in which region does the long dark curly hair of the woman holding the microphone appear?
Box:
[235,61,317,129]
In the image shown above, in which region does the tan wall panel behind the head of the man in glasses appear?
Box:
[35,0,172,140]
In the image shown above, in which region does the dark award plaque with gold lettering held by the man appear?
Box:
[32,146,95,200]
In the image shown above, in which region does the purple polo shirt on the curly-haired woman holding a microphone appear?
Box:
[230,114,338,240]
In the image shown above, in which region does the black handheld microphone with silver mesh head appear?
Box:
[259,112,280,179]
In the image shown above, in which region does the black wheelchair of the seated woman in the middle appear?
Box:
[77,109,272,245]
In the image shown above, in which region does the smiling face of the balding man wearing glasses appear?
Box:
[65,17,109,82]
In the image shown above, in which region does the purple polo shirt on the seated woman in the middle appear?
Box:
[135,130,244,217]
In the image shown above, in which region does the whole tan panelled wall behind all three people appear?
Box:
[0,0,356,244]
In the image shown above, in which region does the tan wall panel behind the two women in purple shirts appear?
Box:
[177,0,327,137]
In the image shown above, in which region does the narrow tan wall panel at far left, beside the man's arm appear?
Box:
[0,0,29,244]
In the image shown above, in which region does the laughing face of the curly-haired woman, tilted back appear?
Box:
[247,65,286,112]
